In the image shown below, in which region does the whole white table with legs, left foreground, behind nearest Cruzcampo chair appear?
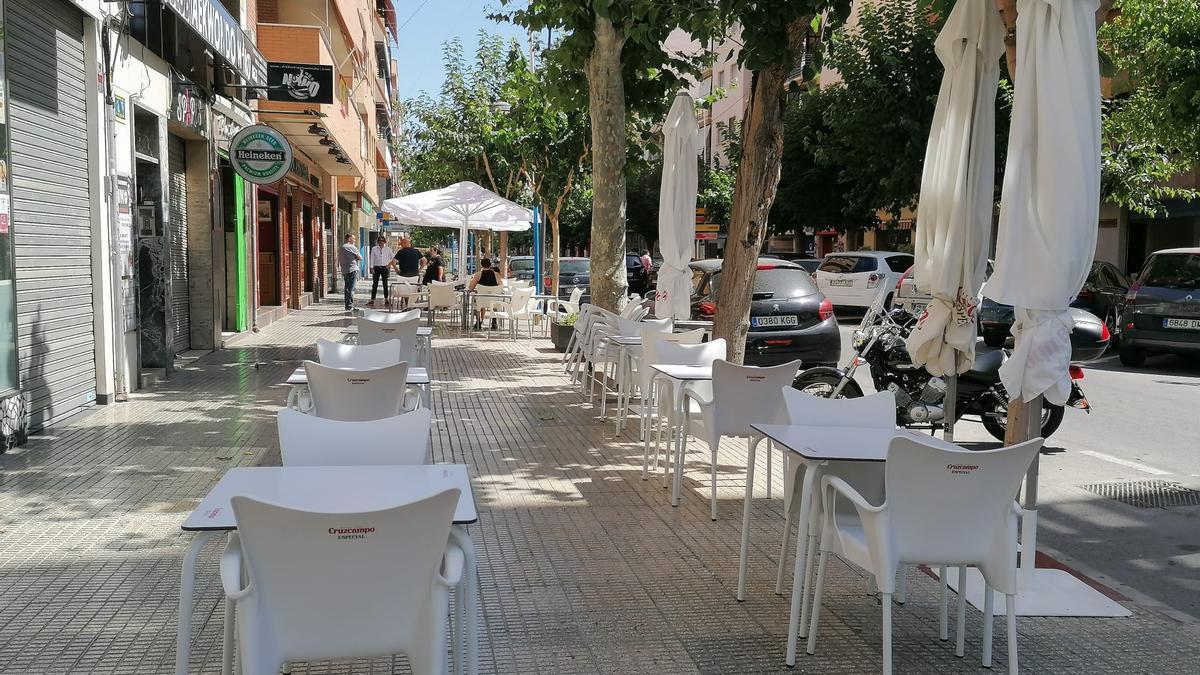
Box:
[175,464,479,675]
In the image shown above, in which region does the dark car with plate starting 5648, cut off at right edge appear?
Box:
[1121,249,1200,366]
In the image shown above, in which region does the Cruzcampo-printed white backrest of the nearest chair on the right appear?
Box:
[884,435,1043,581]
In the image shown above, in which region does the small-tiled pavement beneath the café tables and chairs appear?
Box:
[0,300,1200,674]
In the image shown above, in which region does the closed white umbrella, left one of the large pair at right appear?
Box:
[908,0,1004,374]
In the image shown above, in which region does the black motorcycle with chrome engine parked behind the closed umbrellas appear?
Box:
[792,309,1091,441]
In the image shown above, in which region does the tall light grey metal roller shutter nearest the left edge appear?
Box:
[5,0,96,430]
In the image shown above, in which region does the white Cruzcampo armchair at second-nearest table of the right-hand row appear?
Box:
[676,358,800,521]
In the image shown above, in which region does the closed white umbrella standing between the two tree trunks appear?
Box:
[654,91,698,319]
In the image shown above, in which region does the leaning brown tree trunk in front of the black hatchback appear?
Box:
[713,17,812,363]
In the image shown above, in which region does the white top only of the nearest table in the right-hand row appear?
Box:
[750,424,962,461]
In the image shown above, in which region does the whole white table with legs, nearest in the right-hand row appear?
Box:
[753,424,962,667]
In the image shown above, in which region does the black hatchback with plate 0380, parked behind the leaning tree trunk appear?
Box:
[691,258,841,368]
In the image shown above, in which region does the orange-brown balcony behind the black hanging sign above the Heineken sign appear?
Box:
[258,23,362,177]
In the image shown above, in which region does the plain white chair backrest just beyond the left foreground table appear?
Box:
[278,408,433,466]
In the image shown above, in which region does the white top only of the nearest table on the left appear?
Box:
[182,464,479,531]
